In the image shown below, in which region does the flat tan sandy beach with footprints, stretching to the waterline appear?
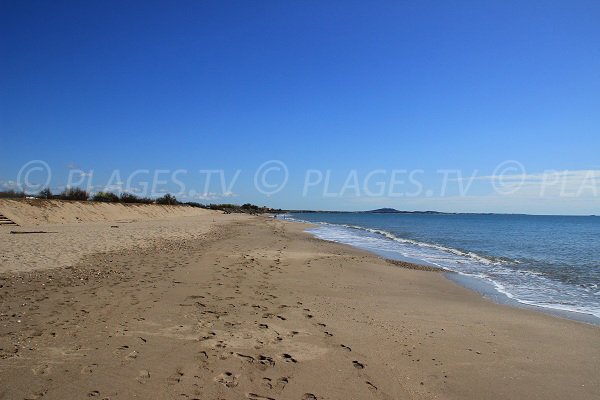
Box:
[0,202,600,400]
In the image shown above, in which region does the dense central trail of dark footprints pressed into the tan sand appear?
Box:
[188,222,377,400]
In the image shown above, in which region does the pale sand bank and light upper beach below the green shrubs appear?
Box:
[0,200,218,272]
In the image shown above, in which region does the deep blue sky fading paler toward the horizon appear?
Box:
[0,0,600,214]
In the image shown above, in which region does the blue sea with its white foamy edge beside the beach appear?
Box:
[281,213,600,317]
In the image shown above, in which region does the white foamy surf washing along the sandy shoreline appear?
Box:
[283,215,600,318]
